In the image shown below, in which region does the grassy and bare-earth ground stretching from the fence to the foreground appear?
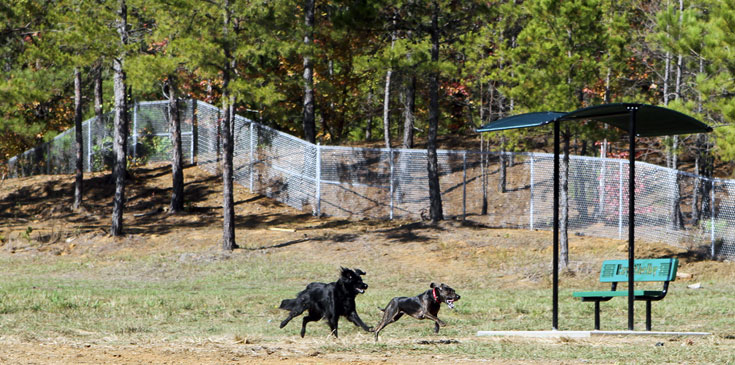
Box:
[0,164,735,364]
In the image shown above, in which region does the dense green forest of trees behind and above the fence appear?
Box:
[0,0,735,165]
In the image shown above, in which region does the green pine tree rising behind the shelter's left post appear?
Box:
[509,0,606,268]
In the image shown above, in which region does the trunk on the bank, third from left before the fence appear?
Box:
[167,76,184,214]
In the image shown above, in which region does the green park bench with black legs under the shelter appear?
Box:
[572,258,679,331]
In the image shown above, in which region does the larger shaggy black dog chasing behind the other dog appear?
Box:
[280,267,372,337]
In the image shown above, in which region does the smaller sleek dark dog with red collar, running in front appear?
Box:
[375,283,459,341]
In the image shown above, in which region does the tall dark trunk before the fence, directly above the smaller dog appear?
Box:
[426,1,444,223]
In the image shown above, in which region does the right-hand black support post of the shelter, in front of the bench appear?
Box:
[628,105,638,331]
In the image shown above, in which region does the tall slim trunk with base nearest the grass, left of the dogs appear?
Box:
[222,0,238,251]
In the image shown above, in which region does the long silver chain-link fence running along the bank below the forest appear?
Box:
[7,101,735,258]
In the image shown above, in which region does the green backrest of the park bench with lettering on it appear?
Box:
[600,258,679,283]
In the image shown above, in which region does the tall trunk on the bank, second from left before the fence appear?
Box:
[110,0,129,236]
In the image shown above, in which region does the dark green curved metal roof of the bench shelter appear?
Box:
[477,104,712,137]
